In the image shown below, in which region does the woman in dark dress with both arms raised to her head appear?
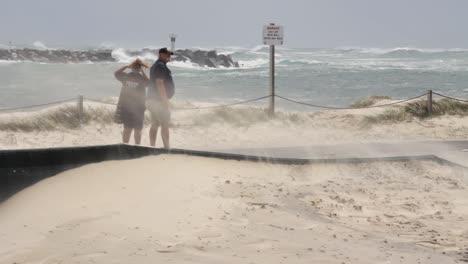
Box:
[114,59,149,145]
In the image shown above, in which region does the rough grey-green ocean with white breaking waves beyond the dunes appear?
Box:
[0,46,468,111]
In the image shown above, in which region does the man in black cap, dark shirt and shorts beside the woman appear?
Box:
[148,48,175,149]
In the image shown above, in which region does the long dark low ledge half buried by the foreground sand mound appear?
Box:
[0,144,459,202]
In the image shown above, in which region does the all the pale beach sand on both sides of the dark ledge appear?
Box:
[0,101,468,264]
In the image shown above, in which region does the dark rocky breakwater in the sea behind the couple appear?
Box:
[0,48,239,68]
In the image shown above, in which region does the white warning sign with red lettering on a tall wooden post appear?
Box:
[263,23,283,116]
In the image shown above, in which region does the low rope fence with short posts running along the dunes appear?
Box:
[0,90,468,114]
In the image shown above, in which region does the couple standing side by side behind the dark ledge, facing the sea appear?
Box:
[114,48,175,148]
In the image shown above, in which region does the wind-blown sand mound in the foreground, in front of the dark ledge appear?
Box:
[0,155,468,264]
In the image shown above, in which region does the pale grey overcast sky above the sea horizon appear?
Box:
[0,0,468,48]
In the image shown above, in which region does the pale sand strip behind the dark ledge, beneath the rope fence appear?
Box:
[0,101,468,150]
